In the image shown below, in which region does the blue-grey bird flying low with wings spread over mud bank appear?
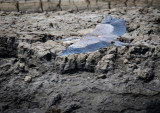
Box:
[59,14,126,56]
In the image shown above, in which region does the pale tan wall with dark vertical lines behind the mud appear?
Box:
[0,0,160,13]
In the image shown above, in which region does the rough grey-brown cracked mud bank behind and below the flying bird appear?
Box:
[0,7,160,113]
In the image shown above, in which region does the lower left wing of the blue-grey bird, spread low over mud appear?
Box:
[59,33,116,56]
